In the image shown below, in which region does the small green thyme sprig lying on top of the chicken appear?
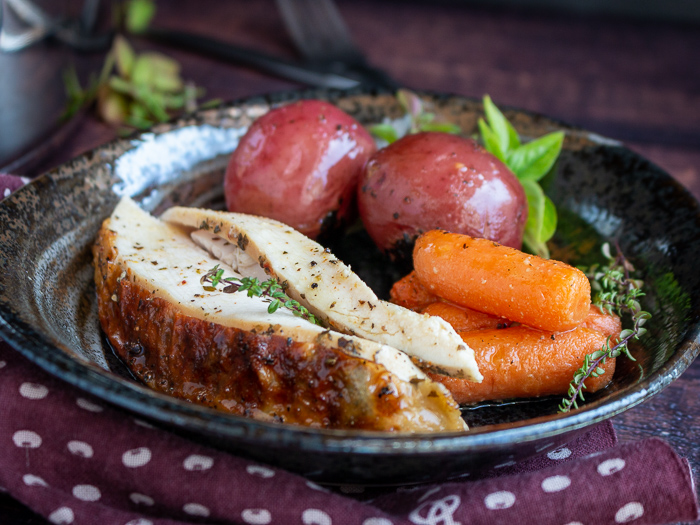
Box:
[199,264,321,325]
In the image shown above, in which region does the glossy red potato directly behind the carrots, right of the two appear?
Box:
[358,132,527,259]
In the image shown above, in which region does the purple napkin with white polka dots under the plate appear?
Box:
[0,174,698,525]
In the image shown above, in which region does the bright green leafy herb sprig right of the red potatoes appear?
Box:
[479,95,564,259]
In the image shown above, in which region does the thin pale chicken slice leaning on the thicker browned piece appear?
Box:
[162,207,482,382]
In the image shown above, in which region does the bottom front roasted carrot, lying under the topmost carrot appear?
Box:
[429,326,615,404]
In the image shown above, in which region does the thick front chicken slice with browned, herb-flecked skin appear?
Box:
[93,198,466,432]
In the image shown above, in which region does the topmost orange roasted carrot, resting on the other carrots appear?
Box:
[413,230,591,332]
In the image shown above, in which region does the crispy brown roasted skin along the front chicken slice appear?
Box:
[93,207,464,431]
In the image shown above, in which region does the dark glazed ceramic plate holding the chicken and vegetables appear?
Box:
[0,91,700,484]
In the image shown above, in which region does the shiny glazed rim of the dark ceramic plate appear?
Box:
[0,90,700,455]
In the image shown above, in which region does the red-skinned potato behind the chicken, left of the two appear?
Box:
[224,100,376,238]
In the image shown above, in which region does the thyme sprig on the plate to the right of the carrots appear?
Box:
[559,243,651,412]
